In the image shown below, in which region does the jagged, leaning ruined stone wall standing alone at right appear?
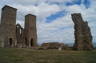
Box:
[72,13,93,50]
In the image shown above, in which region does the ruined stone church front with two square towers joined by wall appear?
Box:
[0,5,37,48]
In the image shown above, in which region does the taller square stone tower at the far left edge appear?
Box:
[0,5,17,47]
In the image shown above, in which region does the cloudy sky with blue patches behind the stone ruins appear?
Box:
[0,0,96,44]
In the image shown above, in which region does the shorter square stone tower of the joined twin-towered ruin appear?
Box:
[24,14,37,47]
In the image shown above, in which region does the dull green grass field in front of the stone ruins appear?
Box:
[0,48,96,63]
